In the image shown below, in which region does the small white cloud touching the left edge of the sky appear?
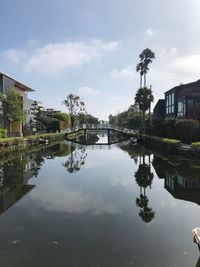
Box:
[0,49,27,64]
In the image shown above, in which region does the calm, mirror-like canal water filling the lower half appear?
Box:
[0,139,200,267]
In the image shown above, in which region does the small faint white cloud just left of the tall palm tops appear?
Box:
[111,66,136,80]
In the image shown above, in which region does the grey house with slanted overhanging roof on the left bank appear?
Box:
[0,72,34,135]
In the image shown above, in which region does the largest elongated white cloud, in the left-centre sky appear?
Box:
[25,39,119,76]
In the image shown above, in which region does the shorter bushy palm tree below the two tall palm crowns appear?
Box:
[135,87,154,130]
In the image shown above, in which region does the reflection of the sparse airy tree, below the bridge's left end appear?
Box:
[63,148,87,173]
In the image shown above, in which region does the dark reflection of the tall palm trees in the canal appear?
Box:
[135,156,155,223]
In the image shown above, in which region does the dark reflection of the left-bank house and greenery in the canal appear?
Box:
[0,144,71,217]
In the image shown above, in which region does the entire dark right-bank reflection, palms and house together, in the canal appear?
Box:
[120,144,200,223]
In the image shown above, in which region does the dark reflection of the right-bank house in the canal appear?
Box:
[153,155,200,205]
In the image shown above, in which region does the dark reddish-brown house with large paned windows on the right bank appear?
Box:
[154,80,200,120]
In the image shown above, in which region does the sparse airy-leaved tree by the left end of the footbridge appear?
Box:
[63,94,86,127]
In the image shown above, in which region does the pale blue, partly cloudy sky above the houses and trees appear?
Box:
[0,0,200,120]
